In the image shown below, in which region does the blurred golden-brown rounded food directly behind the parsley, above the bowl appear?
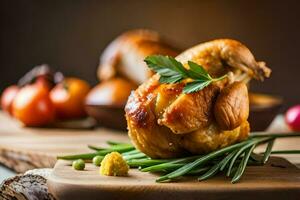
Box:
[97,29,178,84]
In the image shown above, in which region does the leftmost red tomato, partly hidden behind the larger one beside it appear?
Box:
[1,85,19,115]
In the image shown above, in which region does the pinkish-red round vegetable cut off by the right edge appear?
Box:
[285,105,300,131]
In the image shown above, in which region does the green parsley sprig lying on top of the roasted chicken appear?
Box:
[145,55,227,94]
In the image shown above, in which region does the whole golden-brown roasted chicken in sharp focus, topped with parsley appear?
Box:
[125,39,271,158]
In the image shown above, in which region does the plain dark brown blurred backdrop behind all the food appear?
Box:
[0,0,300,109]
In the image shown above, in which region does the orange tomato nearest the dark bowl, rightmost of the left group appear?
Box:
[50,78,90,119]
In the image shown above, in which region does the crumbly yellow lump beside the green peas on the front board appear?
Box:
[100,152,129,176]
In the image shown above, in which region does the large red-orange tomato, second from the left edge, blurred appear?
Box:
[12,84,55,126]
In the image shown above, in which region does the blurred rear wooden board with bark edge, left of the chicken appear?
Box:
[0,112,129,173]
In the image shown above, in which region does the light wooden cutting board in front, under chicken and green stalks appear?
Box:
[48,157,300,200]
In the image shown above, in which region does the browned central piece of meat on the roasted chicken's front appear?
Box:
[156,85,220,134]
